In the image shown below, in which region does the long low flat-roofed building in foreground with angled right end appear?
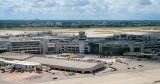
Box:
[26,57,105,73]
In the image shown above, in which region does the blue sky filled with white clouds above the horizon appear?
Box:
[0,0,160,20]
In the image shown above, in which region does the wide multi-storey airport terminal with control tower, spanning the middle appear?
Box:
[0,32,160,55]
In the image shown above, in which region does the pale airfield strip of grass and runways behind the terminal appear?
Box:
[0,27,160,35]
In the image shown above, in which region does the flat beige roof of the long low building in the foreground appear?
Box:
[26,57,102,69]
